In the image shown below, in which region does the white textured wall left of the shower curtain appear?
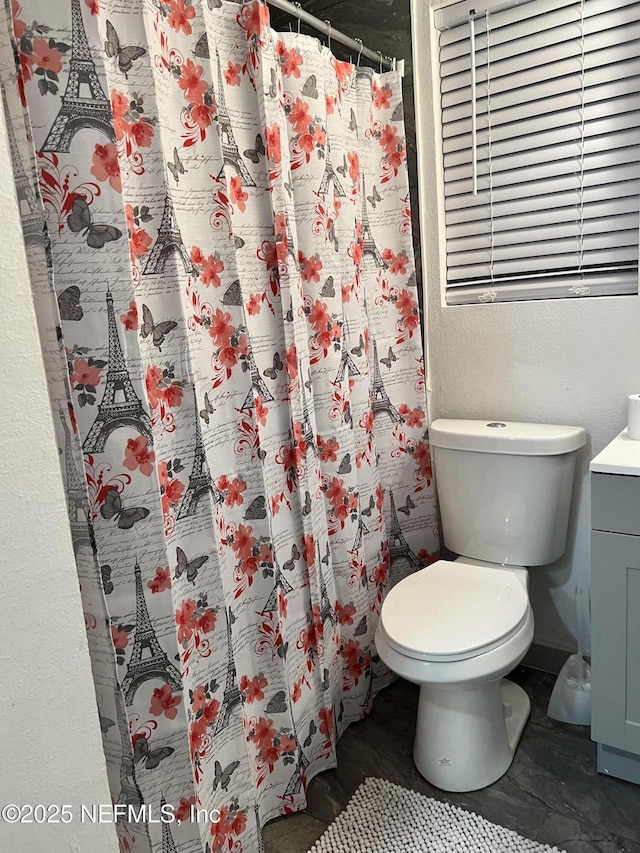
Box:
[0,95,118,853]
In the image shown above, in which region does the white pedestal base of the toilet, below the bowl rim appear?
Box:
[413,678,531,792]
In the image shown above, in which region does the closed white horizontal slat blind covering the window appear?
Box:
[436,0,640,304]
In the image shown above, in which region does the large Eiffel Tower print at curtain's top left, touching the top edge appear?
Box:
[41,0,116,152]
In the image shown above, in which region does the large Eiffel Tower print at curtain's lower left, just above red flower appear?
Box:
[122,561,182,705]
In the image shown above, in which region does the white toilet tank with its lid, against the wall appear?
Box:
[429,419,586,566]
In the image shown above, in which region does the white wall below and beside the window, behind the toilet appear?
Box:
[411,0,640,650]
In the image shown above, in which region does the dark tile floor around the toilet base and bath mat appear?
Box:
[264,667,640,853]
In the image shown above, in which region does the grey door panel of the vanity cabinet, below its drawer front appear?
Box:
[591,531,640,754]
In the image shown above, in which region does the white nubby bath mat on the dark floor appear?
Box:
[308,779,564,853]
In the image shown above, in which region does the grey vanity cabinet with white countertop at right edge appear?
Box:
[591,440,640,783]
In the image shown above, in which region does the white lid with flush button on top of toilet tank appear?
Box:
[429,418,587,456]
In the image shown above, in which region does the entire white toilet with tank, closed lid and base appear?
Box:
[376,420,586,791]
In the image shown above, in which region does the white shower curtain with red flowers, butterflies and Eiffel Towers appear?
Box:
[0,0,437,853]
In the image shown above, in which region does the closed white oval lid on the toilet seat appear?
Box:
[381,560,529,660]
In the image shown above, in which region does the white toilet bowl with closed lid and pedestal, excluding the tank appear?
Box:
[376,560,533,791]
